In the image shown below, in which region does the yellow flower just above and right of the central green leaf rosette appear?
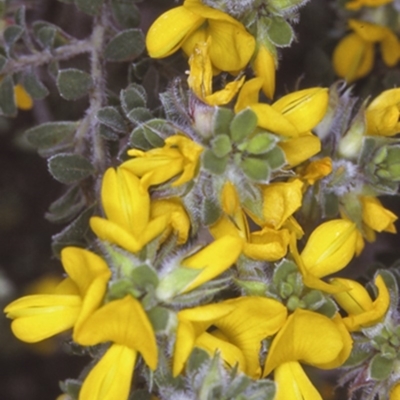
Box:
[235,78,329,142]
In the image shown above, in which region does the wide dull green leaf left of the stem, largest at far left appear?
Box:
[25,121,78,157]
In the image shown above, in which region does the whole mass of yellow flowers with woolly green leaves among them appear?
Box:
[5,0,400,400]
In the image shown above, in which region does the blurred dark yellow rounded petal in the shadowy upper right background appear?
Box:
[333,33,375,83]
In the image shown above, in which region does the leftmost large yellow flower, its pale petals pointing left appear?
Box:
[4,247,111,343]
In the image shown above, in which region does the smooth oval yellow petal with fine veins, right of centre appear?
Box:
[301,219,357,278]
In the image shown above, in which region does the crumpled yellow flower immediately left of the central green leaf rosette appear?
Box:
[120,135,203,186]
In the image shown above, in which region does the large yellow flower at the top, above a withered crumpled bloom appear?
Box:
[146,0,255,72]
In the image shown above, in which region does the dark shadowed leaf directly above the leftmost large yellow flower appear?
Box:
[51,205,94,257]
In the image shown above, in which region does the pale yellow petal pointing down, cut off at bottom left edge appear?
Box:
[79,344,137,400]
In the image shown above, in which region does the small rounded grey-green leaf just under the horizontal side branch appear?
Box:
[57,68,93,100]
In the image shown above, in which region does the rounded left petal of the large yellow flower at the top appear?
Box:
[146,6,205,58]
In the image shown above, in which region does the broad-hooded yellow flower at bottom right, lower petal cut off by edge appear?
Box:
[263,309,352,400]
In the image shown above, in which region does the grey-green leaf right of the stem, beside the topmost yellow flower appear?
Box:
[104,29,145,61]
